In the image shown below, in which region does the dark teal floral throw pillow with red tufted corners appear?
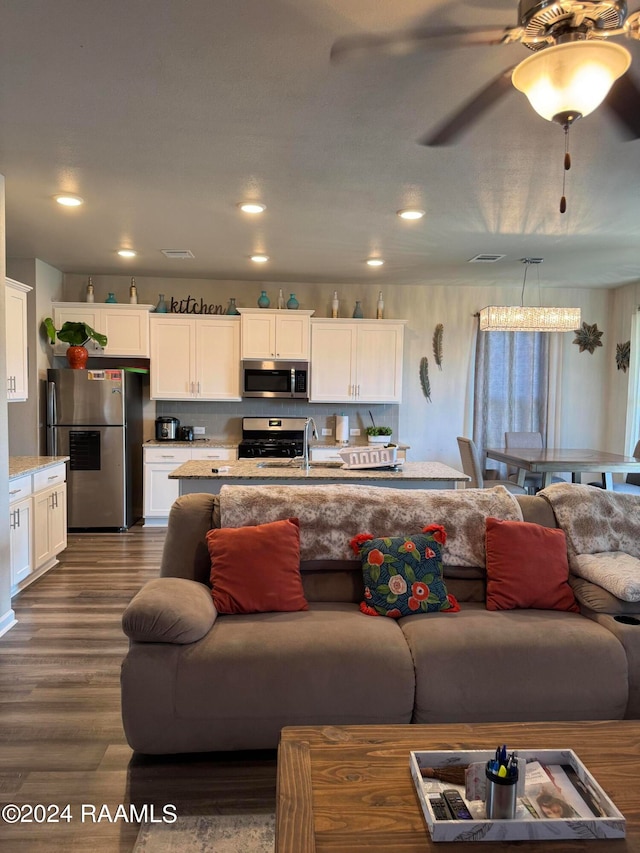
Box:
[349,524,460,619]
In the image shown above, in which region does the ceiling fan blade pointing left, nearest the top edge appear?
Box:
[331,27,522,62]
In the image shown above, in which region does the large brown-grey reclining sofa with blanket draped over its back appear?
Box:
[122,485,640,754]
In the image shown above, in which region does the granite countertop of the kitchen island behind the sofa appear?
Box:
[169,459,469,483]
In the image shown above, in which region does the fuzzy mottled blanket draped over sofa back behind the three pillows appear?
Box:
[220,484,522,568]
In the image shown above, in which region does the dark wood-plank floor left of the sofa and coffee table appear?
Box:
[0,526,276,853]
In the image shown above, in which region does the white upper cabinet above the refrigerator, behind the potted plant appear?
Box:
[53,302,153,358]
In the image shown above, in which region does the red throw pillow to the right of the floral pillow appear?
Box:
[486,518,580,612]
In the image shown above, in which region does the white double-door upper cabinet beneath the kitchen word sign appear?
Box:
[150,314,240,400]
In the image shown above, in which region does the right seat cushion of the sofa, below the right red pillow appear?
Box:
[402,603,628,723]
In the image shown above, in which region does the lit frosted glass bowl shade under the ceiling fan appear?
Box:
[511,41,631,121]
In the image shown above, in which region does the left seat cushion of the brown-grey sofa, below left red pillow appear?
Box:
[174,603,414,749]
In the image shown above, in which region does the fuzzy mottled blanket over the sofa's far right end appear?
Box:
[538,483,640,601]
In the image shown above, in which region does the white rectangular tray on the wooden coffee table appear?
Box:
[409,749,626,841]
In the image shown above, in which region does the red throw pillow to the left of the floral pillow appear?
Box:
[207,518,309,613]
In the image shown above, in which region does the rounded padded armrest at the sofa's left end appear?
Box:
[122,578,218,644]
